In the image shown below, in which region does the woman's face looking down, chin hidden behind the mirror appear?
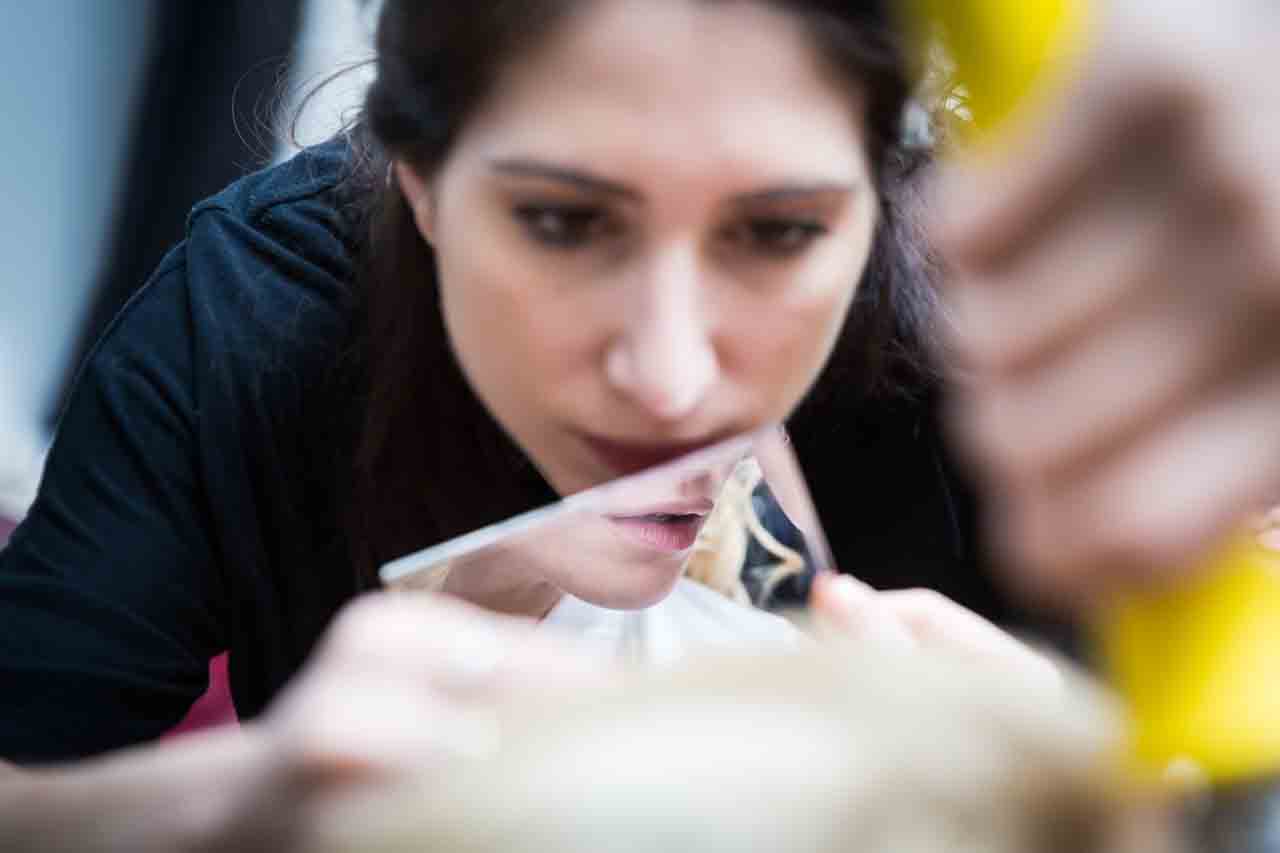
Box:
[397,0,878,493]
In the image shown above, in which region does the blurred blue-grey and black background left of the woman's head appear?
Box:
[0,0,376,532]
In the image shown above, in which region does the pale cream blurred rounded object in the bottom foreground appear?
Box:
[317,643,1167,853]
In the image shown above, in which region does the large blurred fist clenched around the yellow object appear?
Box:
[937,0,1280,603]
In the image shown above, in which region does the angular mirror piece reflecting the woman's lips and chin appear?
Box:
[380,427,831,611]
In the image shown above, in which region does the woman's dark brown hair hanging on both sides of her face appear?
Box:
[347,0,933,583]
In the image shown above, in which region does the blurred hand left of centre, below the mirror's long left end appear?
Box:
[241,593,609,848]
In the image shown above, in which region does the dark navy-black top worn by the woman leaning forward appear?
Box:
[0,136,1034,762]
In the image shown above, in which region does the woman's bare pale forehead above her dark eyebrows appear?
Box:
[462,0,863,179]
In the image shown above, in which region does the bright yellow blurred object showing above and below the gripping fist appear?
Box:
[908,0,1280,784]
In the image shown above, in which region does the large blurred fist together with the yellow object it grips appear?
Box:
[918,0,1280,835]
